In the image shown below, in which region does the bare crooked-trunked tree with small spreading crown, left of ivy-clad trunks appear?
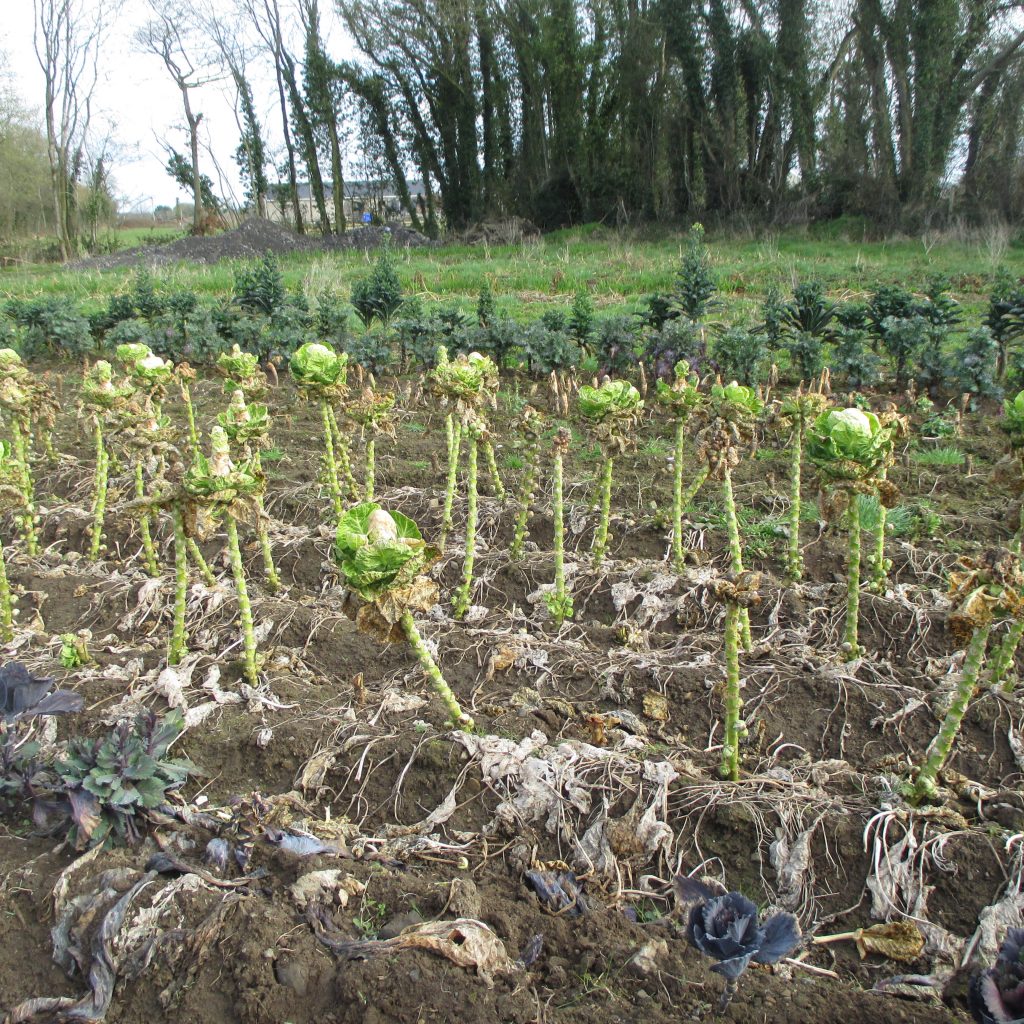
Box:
[135,0,223,234]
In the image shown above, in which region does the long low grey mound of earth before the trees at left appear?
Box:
[72,217,431,270]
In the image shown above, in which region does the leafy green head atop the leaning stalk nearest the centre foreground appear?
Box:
[334,502,432,601]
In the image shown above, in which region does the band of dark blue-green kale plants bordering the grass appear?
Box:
[6,227,1024,397]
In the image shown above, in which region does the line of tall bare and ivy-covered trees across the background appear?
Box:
[9,0,1024,254]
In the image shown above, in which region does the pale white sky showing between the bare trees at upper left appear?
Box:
[0,0,349,210]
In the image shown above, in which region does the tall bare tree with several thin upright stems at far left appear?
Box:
[32,0,120,259]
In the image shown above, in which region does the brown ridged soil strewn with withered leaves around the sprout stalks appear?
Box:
[0,370,1024,1024]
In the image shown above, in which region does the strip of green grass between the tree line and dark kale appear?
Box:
[0,226,1024,321]
